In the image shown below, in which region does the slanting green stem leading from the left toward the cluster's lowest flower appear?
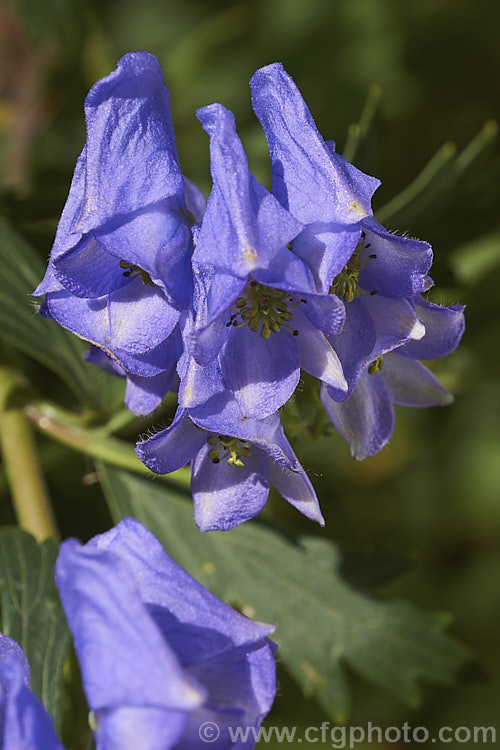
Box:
[25,402,190,488]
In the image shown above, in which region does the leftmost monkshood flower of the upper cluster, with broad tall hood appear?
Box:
[34,52,197,412]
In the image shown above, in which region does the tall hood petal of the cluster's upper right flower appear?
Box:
[250,63,380,224]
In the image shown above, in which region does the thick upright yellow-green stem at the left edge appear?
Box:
[0,368,58,541]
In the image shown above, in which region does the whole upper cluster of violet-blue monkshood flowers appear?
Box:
[35,53,464,530]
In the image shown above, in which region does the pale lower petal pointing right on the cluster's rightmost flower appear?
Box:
[380,350,453,408]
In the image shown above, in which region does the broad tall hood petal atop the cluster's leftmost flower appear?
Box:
[77,52,184,232]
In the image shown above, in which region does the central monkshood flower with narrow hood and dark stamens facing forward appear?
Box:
[188,104,347,419]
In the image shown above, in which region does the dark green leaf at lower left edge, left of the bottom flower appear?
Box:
[0,528,69,727]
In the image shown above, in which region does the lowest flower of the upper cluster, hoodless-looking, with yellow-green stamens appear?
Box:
[136,390,324,531]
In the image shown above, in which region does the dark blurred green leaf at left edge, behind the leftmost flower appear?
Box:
[0,218,123,408]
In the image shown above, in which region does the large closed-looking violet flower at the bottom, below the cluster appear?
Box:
[56,518,276,750]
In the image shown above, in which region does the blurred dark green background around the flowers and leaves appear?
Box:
[0,0,500,747]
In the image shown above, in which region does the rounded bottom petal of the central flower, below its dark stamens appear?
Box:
[219,326,300,419]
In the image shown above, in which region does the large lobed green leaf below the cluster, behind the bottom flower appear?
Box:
[100,466,469,722]
